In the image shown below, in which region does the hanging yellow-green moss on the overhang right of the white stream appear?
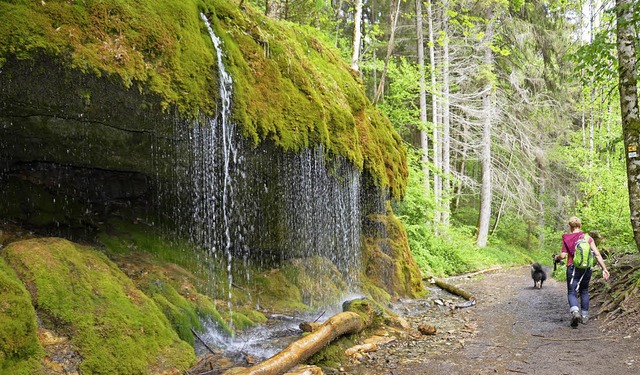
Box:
[212,0,408,197]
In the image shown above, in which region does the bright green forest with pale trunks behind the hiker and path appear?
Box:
[241,0,640,275]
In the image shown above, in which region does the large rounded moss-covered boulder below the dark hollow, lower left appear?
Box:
[4,238,195,374]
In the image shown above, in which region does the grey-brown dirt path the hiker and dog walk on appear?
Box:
[342,267,640,375]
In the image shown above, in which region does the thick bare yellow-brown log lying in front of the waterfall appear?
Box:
[224,311,365,375]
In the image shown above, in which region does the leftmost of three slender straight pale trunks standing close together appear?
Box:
[416,0,430,196]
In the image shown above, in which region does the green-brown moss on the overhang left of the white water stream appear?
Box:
[0,0,215,110]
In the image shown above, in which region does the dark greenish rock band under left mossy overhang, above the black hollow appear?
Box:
[0,60,172,173]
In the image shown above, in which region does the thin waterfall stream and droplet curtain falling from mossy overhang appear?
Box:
[158,15,362,328]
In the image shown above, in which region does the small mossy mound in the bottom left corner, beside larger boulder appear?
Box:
[0,258,44,374]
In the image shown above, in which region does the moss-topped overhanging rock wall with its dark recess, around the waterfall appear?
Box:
[0,0,417,320]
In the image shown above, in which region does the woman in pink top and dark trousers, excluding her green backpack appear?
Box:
[553,216,609,328]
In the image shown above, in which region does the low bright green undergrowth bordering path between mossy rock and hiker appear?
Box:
[394,145,553,277]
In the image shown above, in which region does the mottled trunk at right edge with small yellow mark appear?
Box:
[616,0,640,248]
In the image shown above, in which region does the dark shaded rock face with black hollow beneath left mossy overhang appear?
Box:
[0,59,172,235]
